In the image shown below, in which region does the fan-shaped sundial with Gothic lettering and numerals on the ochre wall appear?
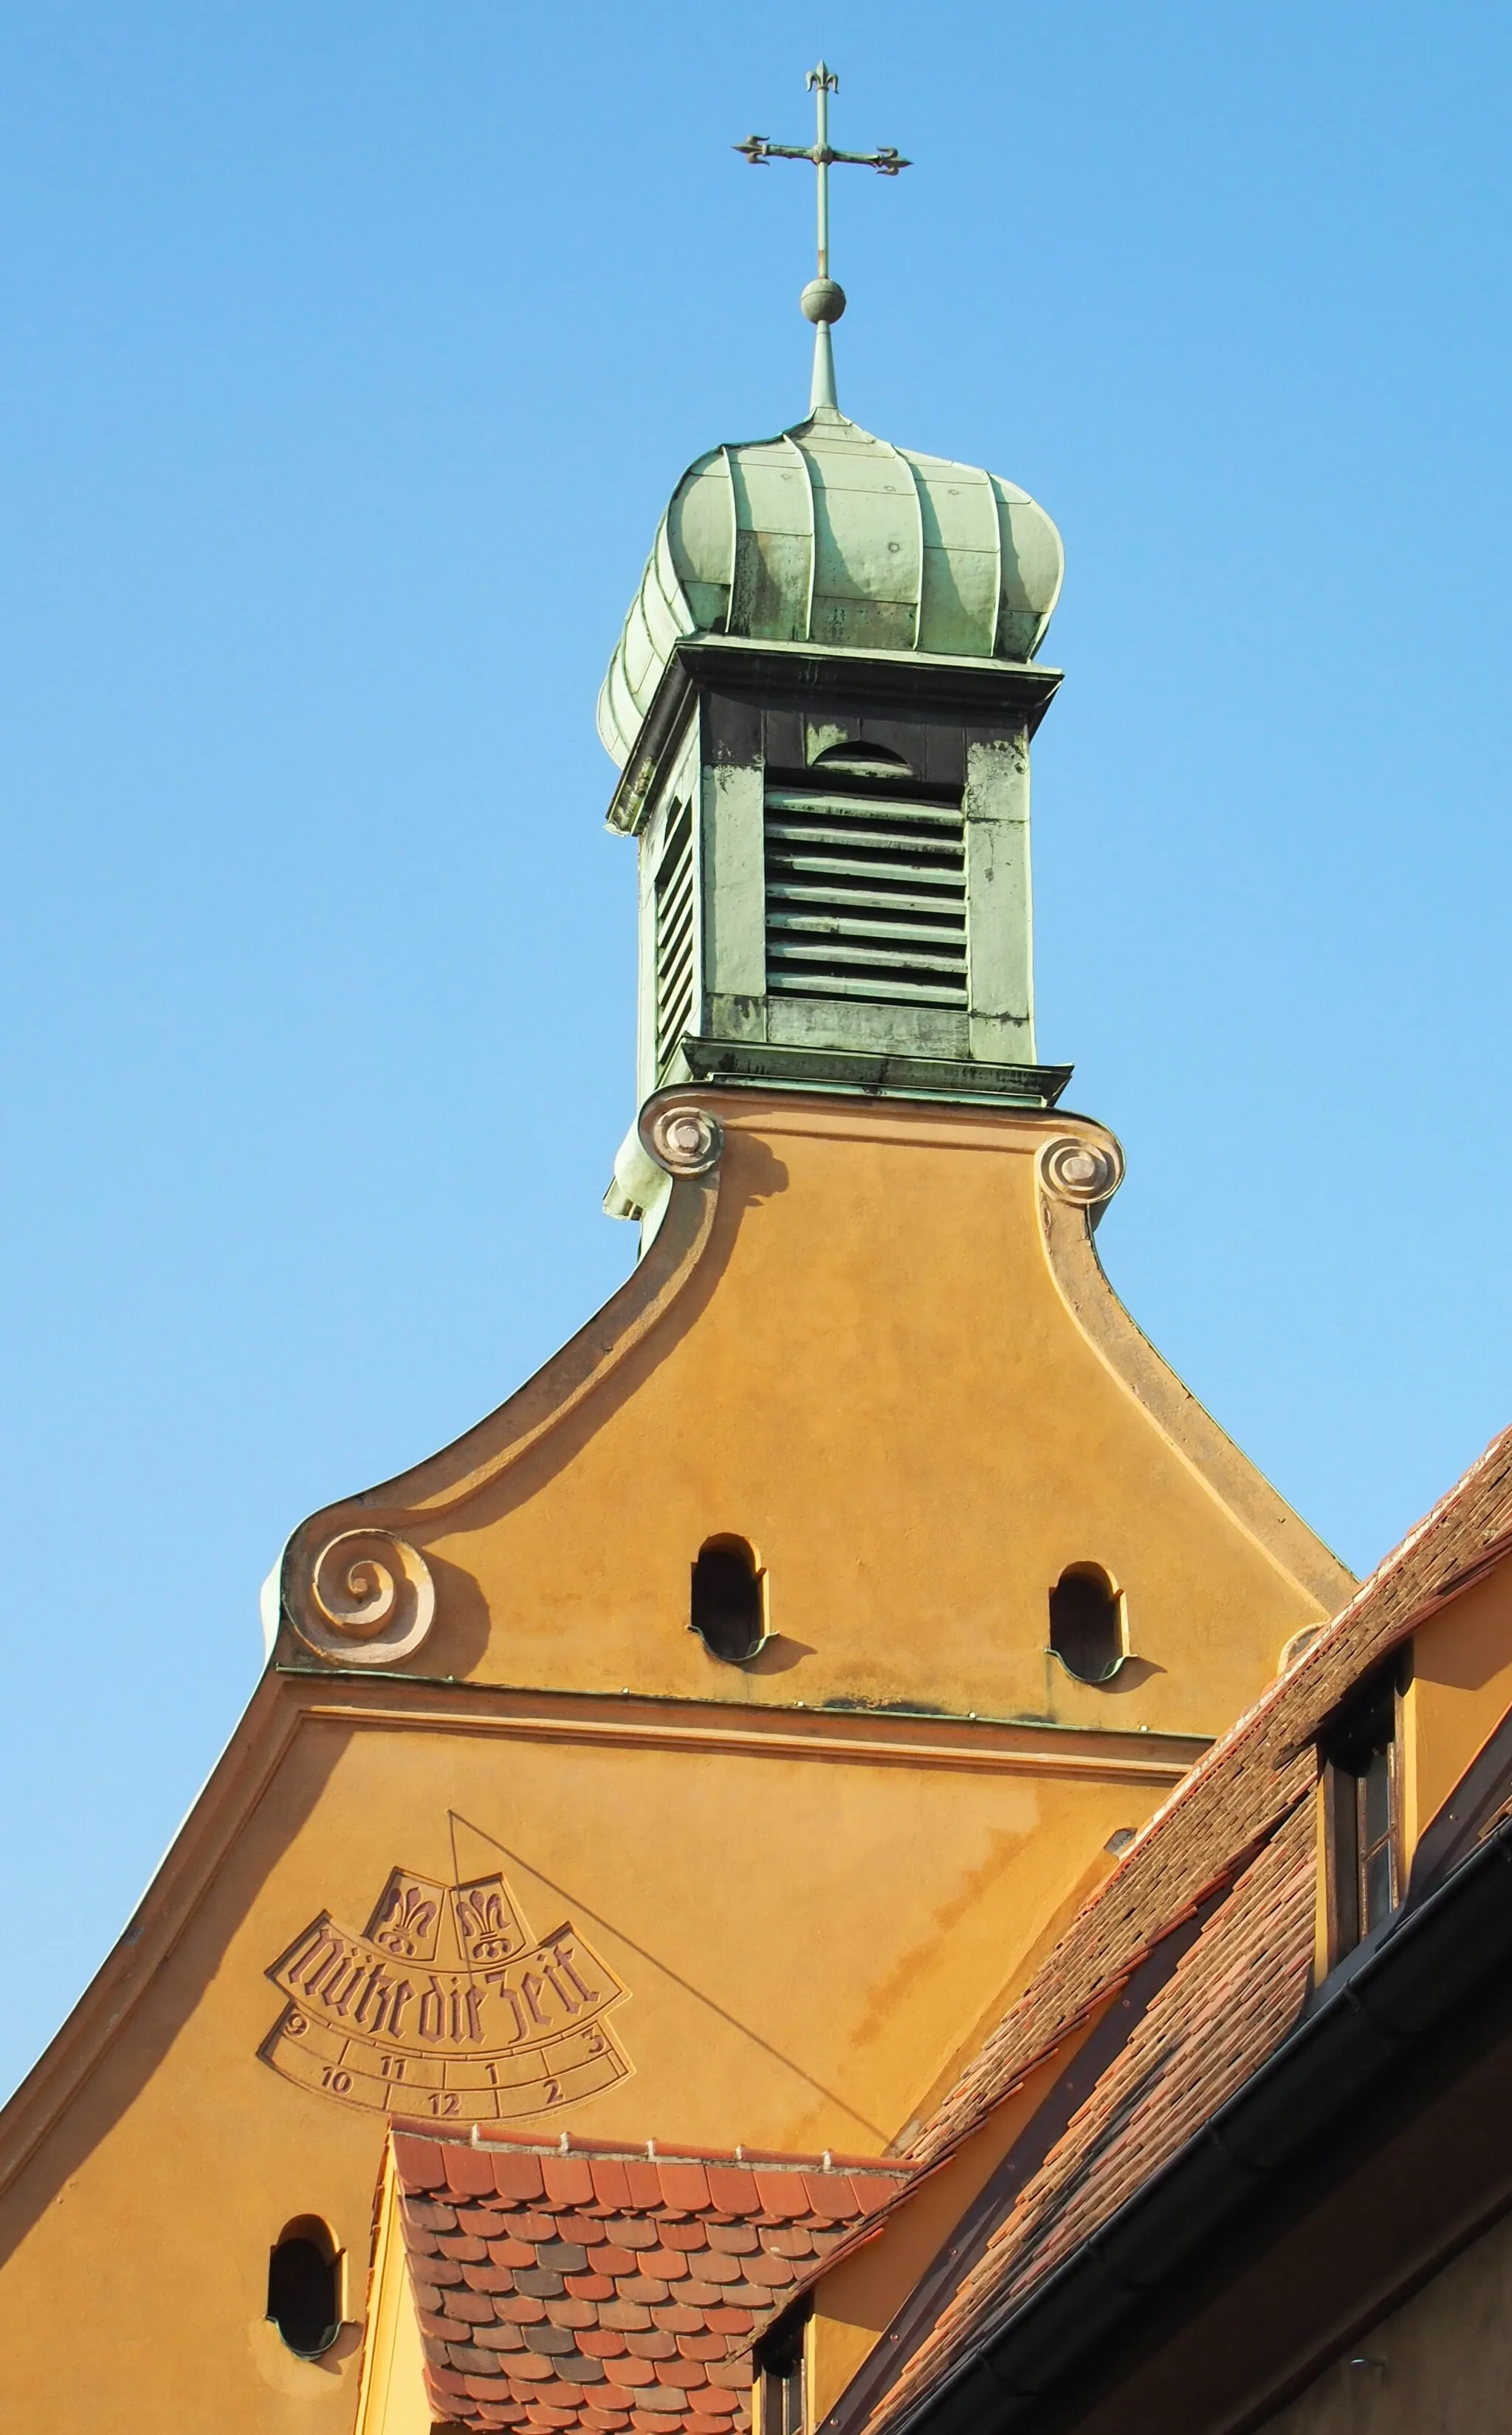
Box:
[258,1868,630,2123]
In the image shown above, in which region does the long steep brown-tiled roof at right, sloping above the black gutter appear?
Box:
[835,1429,1512,2435]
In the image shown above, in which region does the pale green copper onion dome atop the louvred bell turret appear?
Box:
[599,407,1064,767]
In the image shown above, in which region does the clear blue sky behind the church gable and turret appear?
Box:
[0,0,1512,2082]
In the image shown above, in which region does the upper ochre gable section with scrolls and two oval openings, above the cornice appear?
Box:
[280,1093,1349,1734]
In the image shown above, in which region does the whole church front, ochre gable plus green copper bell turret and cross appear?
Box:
[0,68,1351,2435]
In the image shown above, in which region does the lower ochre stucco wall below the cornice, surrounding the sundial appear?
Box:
[0,1677,1178,2435]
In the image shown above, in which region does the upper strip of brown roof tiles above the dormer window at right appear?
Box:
[904,1429,1512,2165]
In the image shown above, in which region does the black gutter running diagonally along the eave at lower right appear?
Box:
[896,1819,1512,2435]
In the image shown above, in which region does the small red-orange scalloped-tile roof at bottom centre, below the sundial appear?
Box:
[394,2126,915,2435]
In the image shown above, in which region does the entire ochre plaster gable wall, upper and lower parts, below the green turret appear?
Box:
[0,1093,1347,2435]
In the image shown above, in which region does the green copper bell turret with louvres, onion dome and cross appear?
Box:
[599,61,1069,1210]
